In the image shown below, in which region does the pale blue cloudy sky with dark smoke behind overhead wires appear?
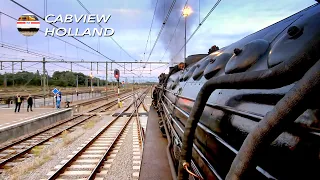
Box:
[0,0,316,79]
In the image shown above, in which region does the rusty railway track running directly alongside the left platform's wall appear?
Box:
[0,89,143,172]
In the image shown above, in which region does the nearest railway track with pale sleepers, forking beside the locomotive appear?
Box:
[47,90,148,180]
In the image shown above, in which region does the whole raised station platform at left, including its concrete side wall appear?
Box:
[0,108,73,143]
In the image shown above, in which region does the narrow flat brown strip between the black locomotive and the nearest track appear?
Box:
[139,107,172,180]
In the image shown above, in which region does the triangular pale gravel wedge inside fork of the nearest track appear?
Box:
[104,121,133,180]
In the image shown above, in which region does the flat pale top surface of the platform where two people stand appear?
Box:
[0,108,67,130]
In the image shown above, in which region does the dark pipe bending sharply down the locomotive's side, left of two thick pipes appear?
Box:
[178,47,320,180]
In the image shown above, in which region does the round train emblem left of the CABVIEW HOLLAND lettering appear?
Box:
[17,14,40,36]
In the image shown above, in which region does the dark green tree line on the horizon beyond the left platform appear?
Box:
[0,71,106,87]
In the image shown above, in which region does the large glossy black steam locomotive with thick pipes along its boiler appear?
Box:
[153,3,320,180]
